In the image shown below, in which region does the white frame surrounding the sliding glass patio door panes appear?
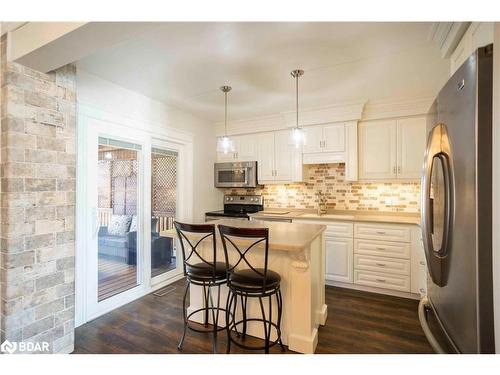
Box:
[75,103,193,327]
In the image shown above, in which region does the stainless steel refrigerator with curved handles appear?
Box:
[419,45,495,353]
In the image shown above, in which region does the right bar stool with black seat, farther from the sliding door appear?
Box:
[219,225,285,353]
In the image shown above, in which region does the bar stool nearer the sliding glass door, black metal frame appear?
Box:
[174,222,227,353]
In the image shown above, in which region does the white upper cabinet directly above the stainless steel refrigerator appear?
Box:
[450,22,494,75]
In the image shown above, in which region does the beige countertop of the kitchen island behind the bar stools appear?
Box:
[210,219,326,251]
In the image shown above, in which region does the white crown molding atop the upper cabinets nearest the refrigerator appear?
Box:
[362,96,434,121]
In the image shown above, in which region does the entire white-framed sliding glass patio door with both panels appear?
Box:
[77,119,187,321]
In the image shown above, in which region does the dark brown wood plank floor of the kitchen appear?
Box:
[75,280,432,354]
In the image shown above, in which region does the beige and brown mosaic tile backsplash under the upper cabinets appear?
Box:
[225,163,420,212]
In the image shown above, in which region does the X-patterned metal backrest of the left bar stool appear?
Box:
[174,221,217,279]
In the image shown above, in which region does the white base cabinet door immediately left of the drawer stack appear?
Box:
[325,236,353,283]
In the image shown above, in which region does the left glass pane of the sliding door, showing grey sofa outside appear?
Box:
[97,137,142,302]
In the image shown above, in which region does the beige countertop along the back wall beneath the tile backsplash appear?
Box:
[249,208,420,225]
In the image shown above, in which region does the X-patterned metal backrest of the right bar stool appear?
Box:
[219,225,269,291]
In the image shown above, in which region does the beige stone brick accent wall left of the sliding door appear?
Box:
[0,33,76,353]
